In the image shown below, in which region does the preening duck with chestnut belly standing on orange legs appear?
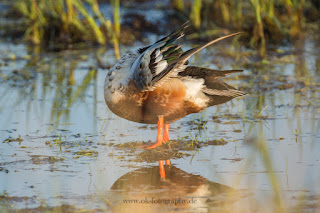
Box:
[104,23,245,148]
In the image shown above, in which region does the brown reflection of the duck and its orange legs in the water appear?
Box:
[111,160,238,212]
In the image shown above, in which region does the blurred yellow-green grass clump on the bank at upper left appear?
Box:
[14,0,120,56]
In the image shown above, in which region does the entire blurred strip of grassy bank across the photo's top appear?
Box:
[2,0,320,58]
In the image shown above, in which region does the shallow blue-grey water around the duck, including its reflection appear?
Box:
[0,28,320,212]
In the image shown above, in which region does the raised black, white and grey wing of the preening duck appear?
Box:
[132,23,241,91]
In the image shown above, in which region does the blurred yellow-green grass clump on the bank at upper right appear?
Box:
[171,0,320,56]
